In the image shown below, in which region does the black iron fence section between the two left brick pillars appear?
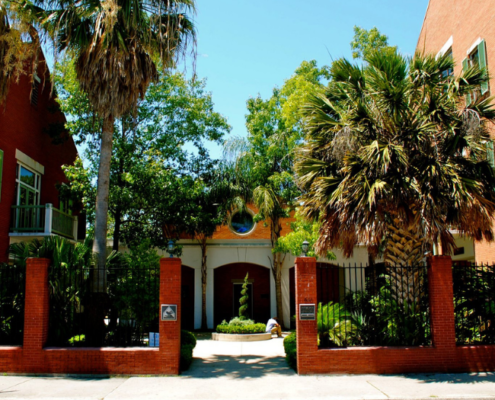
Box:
[47,266,160,347]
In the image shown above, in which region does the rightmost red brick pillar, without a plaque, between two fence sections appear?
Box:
[428,256,456,360]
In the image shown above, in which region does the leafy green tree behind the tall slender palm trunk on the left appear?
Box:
[54,60,230,250]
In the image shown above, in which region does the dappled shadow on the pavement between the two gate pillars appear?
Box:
[182,354,296,379]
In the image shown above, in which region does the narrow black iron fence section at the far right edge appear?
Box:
[452,262,495,345]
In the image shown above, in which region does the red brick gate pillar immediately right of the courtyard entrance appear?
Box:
[296,257,318,375]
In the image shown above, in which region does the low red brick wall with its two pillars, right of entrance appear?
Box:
[296,256,495,375]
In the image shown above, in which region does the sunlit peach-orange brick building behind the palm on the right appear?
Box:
[417,0,495,262]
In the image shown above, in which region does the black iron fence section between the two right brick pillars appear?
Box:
[317,263,431,348]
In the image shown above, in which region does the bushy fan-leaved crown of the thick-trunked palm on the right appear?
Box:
[295,52,495,262]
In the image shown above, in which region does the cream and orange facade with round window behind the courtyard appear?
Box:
[157,205,368,329]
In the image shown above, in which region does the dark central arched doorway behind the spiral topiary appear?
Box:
[213,263,270,326]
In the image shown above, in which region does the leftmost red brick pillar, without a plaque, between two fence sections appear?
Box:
[22,258,50,372]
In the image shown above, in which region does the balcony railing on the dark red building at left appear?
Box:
[10,204,77,240]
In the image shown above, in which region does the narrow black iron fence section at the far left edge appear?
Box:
[0,264,26,346]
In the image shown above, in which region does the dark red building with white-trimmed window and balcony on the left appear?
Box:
[0,54,79,262]
